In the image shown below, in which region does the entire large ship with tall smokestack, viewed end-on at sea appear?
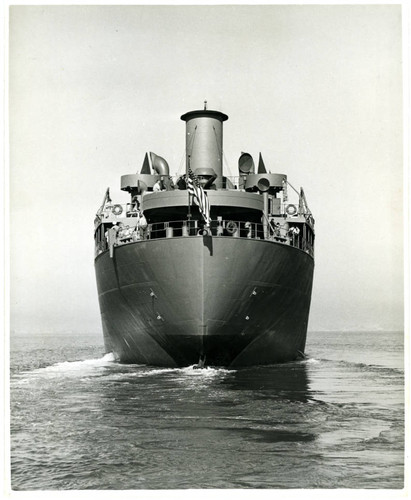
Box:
[94,102,315,369]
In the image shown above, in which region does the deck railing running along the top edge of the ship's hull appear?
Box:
[96,220,314,257]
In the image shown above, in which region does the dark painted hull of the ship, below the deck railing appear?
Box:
[95,236,314,367]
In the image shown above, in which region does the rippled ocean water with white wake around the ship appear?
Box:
[10,332,404,490]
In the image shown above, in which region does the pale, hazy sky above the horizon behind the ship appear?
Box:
[8,4,404,333]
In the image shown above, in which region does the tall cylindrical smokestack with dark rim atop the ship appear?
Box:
[181,108,228,187]
